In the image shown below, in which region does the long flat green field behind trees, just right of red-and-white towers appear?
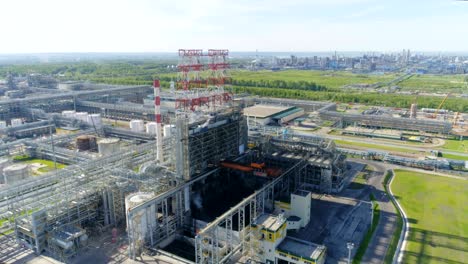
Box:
[232,70,396,88]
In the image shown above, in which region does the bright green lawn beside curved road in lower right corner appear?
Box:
[392,170,468,264]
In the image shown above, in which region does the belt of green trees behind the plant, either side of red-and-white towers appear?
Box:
[0,61,468,112]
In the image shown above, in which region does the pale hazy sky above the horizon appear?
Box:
[0,0,468,53]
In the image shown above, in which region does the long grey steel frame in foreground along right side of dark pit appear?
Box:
[195,160,307,264]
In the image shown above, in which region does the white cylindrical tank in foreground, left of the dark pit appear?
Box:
[125,192,157,248]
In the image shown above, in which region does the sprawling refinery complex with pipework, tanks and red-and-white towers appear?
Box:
[0,49,466,264]
